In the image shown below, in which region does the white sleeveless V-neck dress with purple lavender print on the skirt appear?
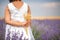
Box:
[5,2,35,40]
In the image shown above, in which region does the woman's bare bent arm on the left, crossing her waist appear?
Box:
[5,7,26,26]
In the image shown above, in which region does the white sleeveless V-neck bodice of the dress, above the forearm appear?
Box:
[8,2,28,22]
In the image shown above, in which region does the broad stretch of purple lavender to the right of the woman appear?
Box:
[32,20,60,40]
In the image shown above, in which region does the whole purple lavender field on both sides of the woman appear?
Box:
[0,19,60,40]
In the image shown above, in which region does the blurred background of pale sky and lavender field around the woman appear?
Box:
[0,0,60,40]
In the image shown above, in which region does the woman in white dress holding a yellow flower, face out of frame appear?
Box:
[5,0,34,40]
